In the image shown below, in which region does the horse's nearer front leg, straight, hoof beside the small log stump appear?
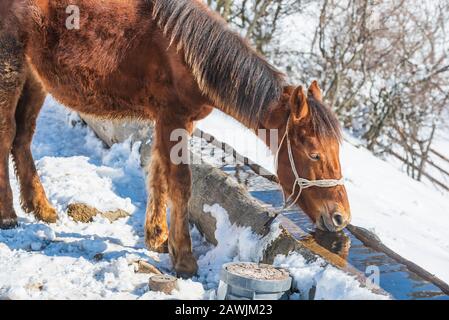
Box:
[146,119,198,278]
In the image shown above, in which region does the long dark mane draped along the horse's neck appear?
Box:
[151,0,284,128]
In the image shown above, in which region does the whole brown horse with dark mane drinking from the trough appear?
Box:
[0,0,350,276]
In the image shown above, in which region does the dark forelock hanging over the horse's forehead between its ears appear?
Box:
[307,97,342,143]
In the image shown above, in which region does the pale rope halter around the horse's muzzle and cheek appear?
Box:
[274,117,344,210]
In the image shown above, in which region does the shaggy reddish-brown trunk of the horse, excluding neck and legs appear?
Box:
[23,0,202,118]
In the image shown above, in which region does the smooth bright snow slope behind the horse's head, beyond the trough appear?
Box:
[198,112,449,282]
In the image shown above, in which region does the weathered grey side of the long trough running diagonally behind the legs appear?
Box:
[82,115,390,297]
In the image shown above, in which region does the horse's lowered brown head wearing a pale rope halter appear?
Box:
[262,82,351,232]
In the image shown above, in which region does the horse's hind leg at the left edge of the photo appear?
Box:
[0,34,26,229]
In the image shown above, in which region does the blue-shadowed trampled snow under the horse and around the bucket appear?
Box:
[0,98,384,300]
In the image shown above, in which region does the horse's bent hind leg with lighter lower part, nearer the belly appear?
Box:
[12,73,57,223]
